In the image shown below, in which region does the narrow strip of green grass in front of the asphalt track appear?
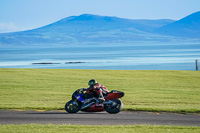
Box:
[0,124,200,133]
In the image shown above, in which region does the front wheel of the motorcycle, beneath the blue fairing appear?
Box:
[65,100,81,113]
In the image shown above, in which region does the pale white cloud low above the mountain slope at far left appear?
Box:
[0,22,20,33]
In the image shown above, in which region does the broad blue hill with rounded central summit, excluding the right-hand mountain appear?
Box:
[0,14,174,45]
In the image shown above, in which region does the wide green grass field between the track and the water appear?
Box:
[0,68,200,113]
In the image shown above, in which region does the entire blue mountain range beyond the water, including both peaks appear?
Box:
[0,12,200,45]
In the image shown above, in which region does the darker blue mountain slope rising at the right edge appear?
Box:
[155,11,200,38]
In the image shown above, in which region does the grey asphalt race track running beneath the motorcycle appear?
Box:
[0,110,200,126]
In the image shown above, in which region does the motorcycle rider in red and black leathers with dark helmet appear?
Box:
[82,79,109,103]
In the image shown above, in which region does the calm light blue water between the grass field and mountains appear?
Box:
[0,43,200,70]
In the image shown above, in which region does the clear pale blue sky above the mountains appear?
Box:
[0,0,200,33]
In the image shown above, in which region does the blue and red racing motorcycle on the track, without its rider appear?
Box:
[65,89,124,114]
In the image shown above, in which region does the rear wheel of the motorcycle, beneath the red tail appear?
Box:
[104,99,123,114]
